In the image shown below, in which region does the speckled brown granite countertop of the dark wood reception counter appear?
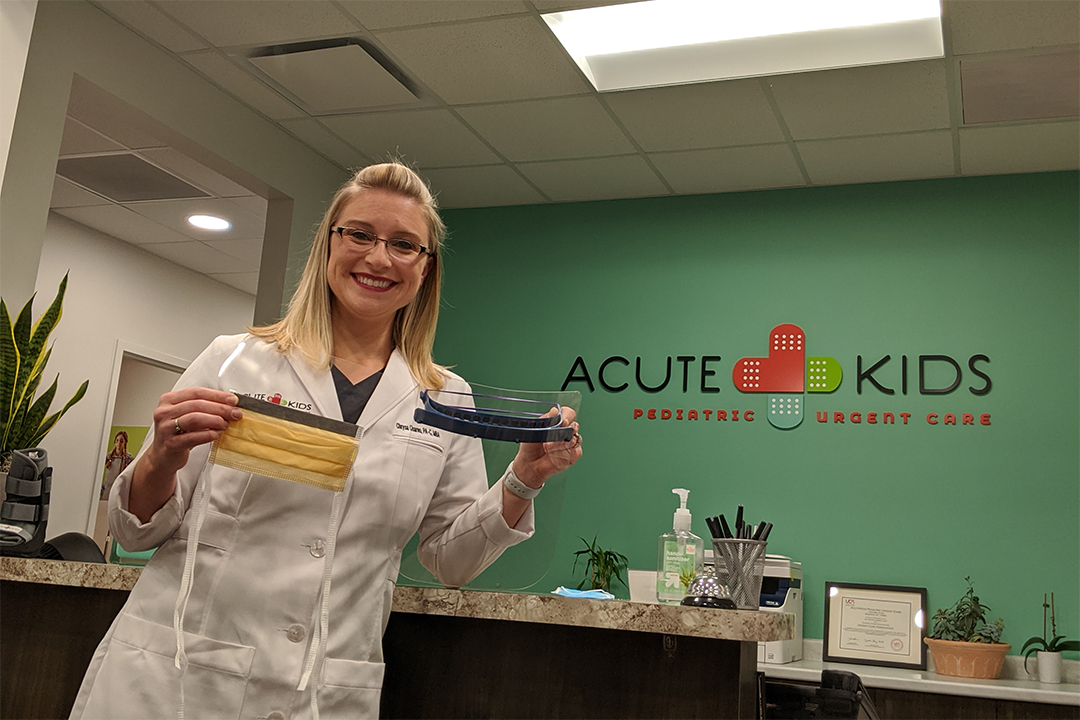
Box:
[0,557,795,642]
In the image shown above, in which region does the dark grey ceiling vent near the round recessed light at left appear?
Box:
[56,152,210,203]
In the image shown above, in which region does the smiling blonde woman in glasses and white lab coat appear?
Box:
[72,163,581,719]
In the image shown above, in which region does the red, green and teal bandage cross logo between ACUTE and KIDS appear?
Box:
[731,323,843,430]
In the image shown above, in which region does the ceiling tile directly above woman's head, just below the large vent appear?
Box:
[320,110,499,167]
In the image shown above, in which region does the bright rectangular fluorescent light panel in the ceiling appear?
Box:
[543,0,945,92]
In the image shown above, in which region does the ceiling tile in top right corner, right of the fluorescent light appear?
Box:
[946,0,1080,55]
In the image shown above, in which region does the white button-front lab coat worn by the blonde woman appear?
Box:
[71,336,532,720]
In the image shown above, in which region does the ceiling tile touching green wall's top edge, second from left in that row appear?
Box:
[517,155,671,202]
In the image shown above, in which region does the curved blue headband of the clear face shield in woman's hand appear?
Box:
[414,390,573,443]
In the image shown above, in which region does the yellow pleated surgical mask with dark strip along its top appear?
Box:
[210,395,363,492]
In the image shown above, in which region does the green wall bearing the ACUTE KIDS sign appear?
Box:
[425,173,1080,652]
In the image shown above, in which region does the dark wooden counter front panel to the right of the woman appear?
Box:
[380,613,757,719]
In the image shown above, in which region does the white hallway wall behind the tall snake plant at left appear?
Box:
[34,213,255,538]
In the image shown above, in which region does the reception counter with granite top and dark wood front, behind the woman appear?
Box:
[0,558,795,718]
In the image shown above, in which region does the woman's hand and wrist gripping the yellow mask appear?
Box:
[127,388,244,522]
